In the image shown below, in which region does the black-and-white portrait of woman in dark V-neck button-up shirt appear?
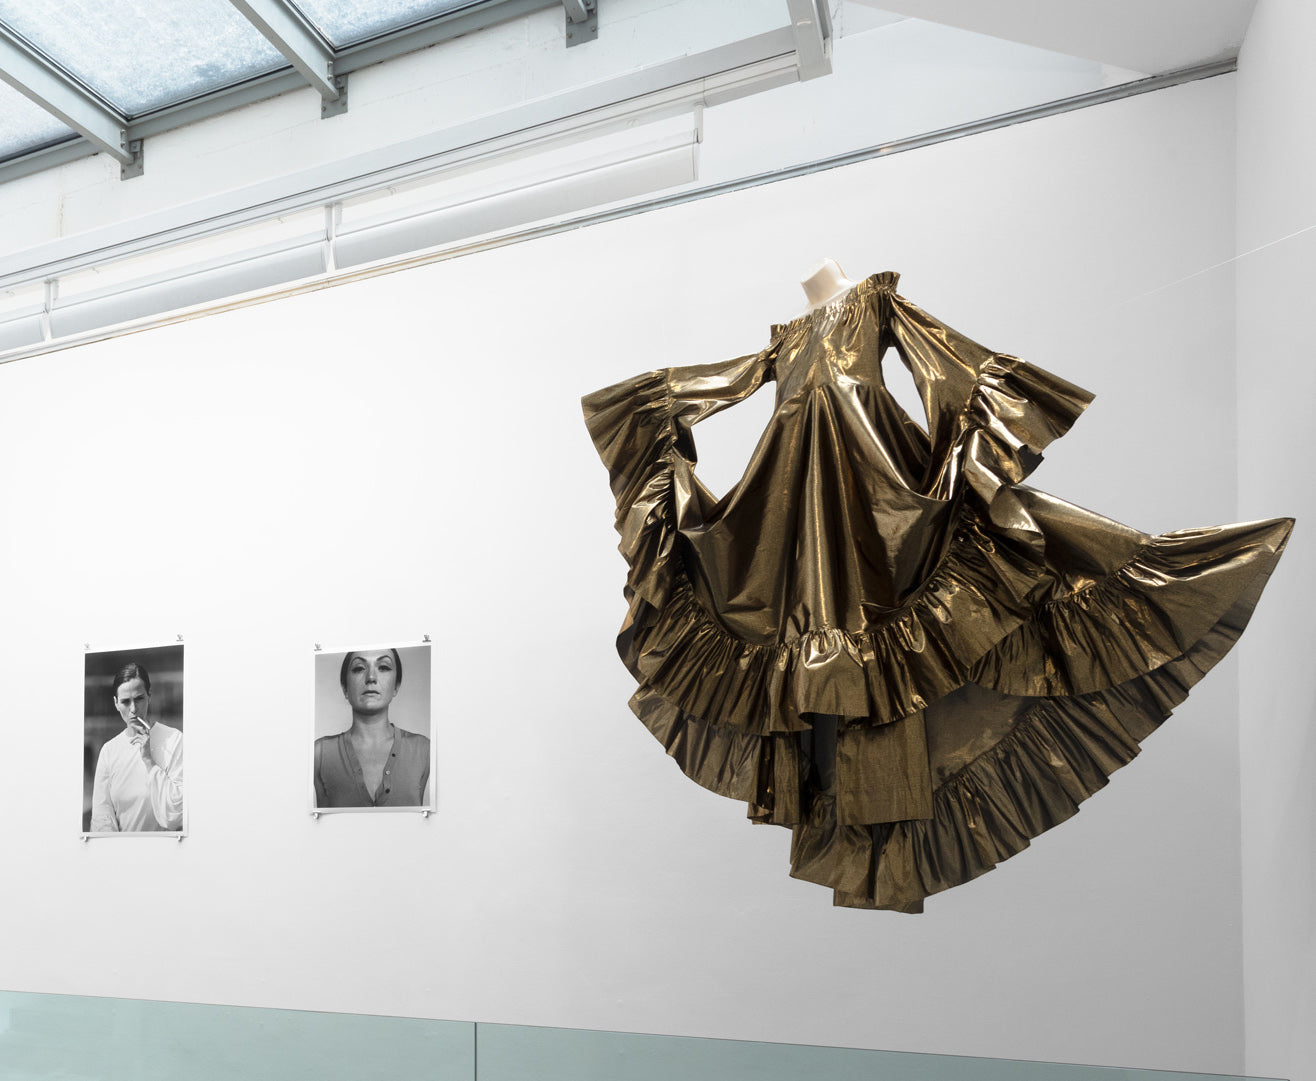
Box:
[312,644,434,812]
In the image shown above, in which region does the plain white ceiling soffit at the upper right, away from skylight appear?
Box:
[858,0,1257,75]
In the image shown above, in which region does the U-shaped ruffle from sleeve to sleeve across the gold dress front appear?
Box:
[583,350,1091,735]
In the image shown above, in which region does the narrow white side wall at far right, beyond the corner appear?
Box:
[1237,0,1316,1081]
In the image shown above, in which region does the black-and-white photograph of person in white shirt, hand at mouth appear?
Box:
[82,643,187,837]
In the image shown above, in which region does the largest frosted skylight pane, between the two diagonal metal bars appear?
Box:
[0,0,287,117]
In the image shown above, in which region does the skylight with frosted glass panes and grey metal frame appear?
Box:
[0,0,557,176]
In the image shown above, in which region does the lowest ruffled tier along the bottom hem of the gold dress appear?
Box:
[632,520,1291,912]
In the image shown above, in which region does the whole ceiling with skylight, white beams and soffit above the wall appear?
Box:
[0,0,1255,359]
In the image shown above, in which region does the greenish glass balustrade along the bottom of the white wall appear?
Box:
[0,991,1284,1081]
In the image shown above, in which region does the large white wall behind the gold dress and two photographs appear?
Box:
[0,73,1263,1072]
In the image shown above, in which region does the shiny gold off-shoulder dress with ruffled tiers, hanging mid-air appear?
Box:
[583,274,1292,912]
